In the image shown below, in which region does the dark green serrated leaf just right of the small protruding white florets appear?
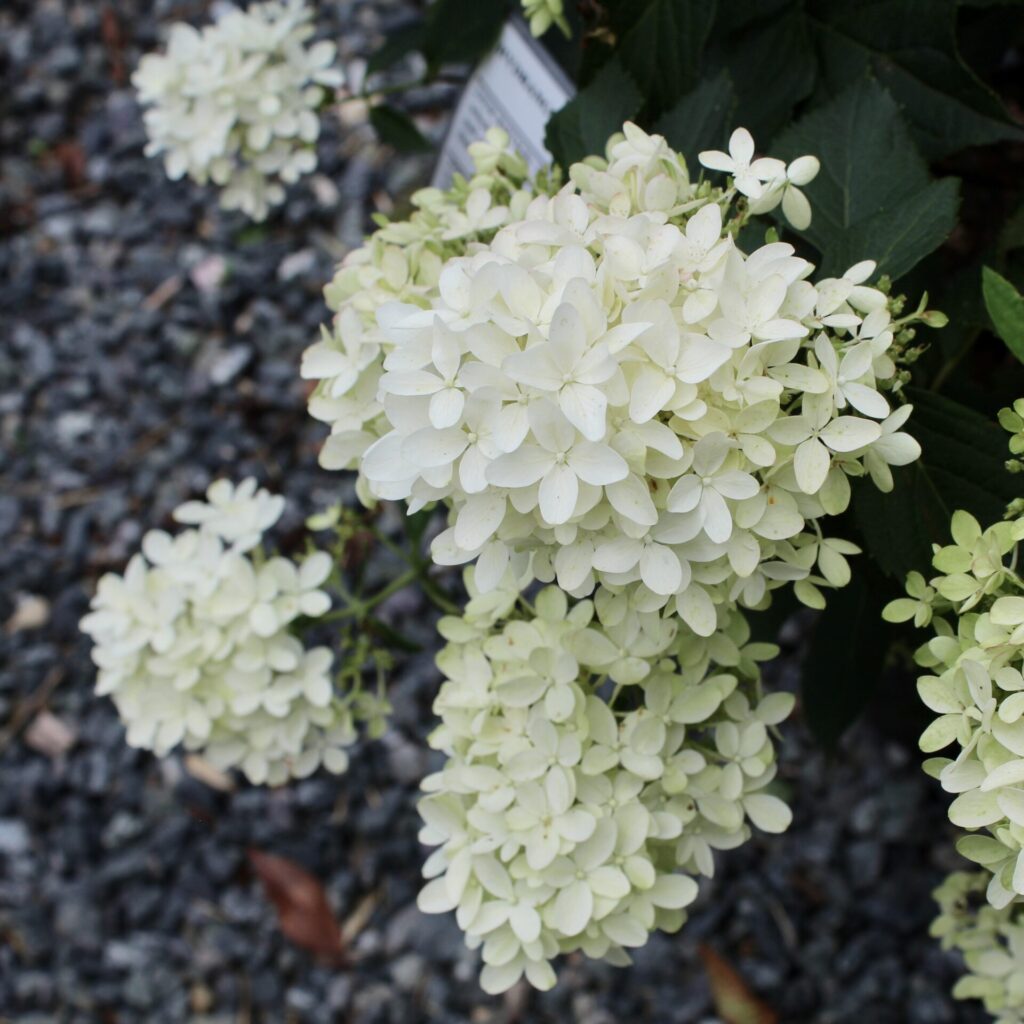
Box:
[772,79,957,278]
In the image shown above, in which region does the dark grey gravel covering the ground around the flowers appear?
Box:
[0,0,985,1024]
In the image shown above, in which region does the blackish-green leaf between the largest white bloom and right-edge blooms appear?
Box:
[853,388,1020,580]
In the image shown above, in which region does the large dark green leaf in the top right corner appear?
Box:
[812,0,1024,159]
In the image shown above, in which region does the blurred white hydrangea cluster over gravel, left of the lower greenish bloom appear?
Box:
[82,478,355,784]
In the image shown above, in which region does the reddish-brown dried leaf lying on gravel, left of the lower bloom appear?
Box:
[249,850,345,966]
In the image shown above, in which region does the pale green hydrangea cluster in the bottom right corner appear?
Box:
[931,871,1024,1024]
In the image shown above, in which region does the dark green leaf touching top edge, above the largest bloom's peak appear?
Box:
[617,0,715,113]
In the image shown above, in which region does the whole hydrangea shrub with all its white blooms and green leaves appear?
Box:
[82,0,1024,1011]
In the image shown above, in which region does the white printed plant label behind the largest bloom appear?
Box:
[433,18,574,188]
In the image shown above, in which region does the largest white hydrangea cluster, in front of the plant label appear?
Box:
[304,125,920,636]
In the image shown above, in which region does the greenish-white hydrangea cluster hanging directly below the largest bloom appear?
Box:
[419,570,793,992]
